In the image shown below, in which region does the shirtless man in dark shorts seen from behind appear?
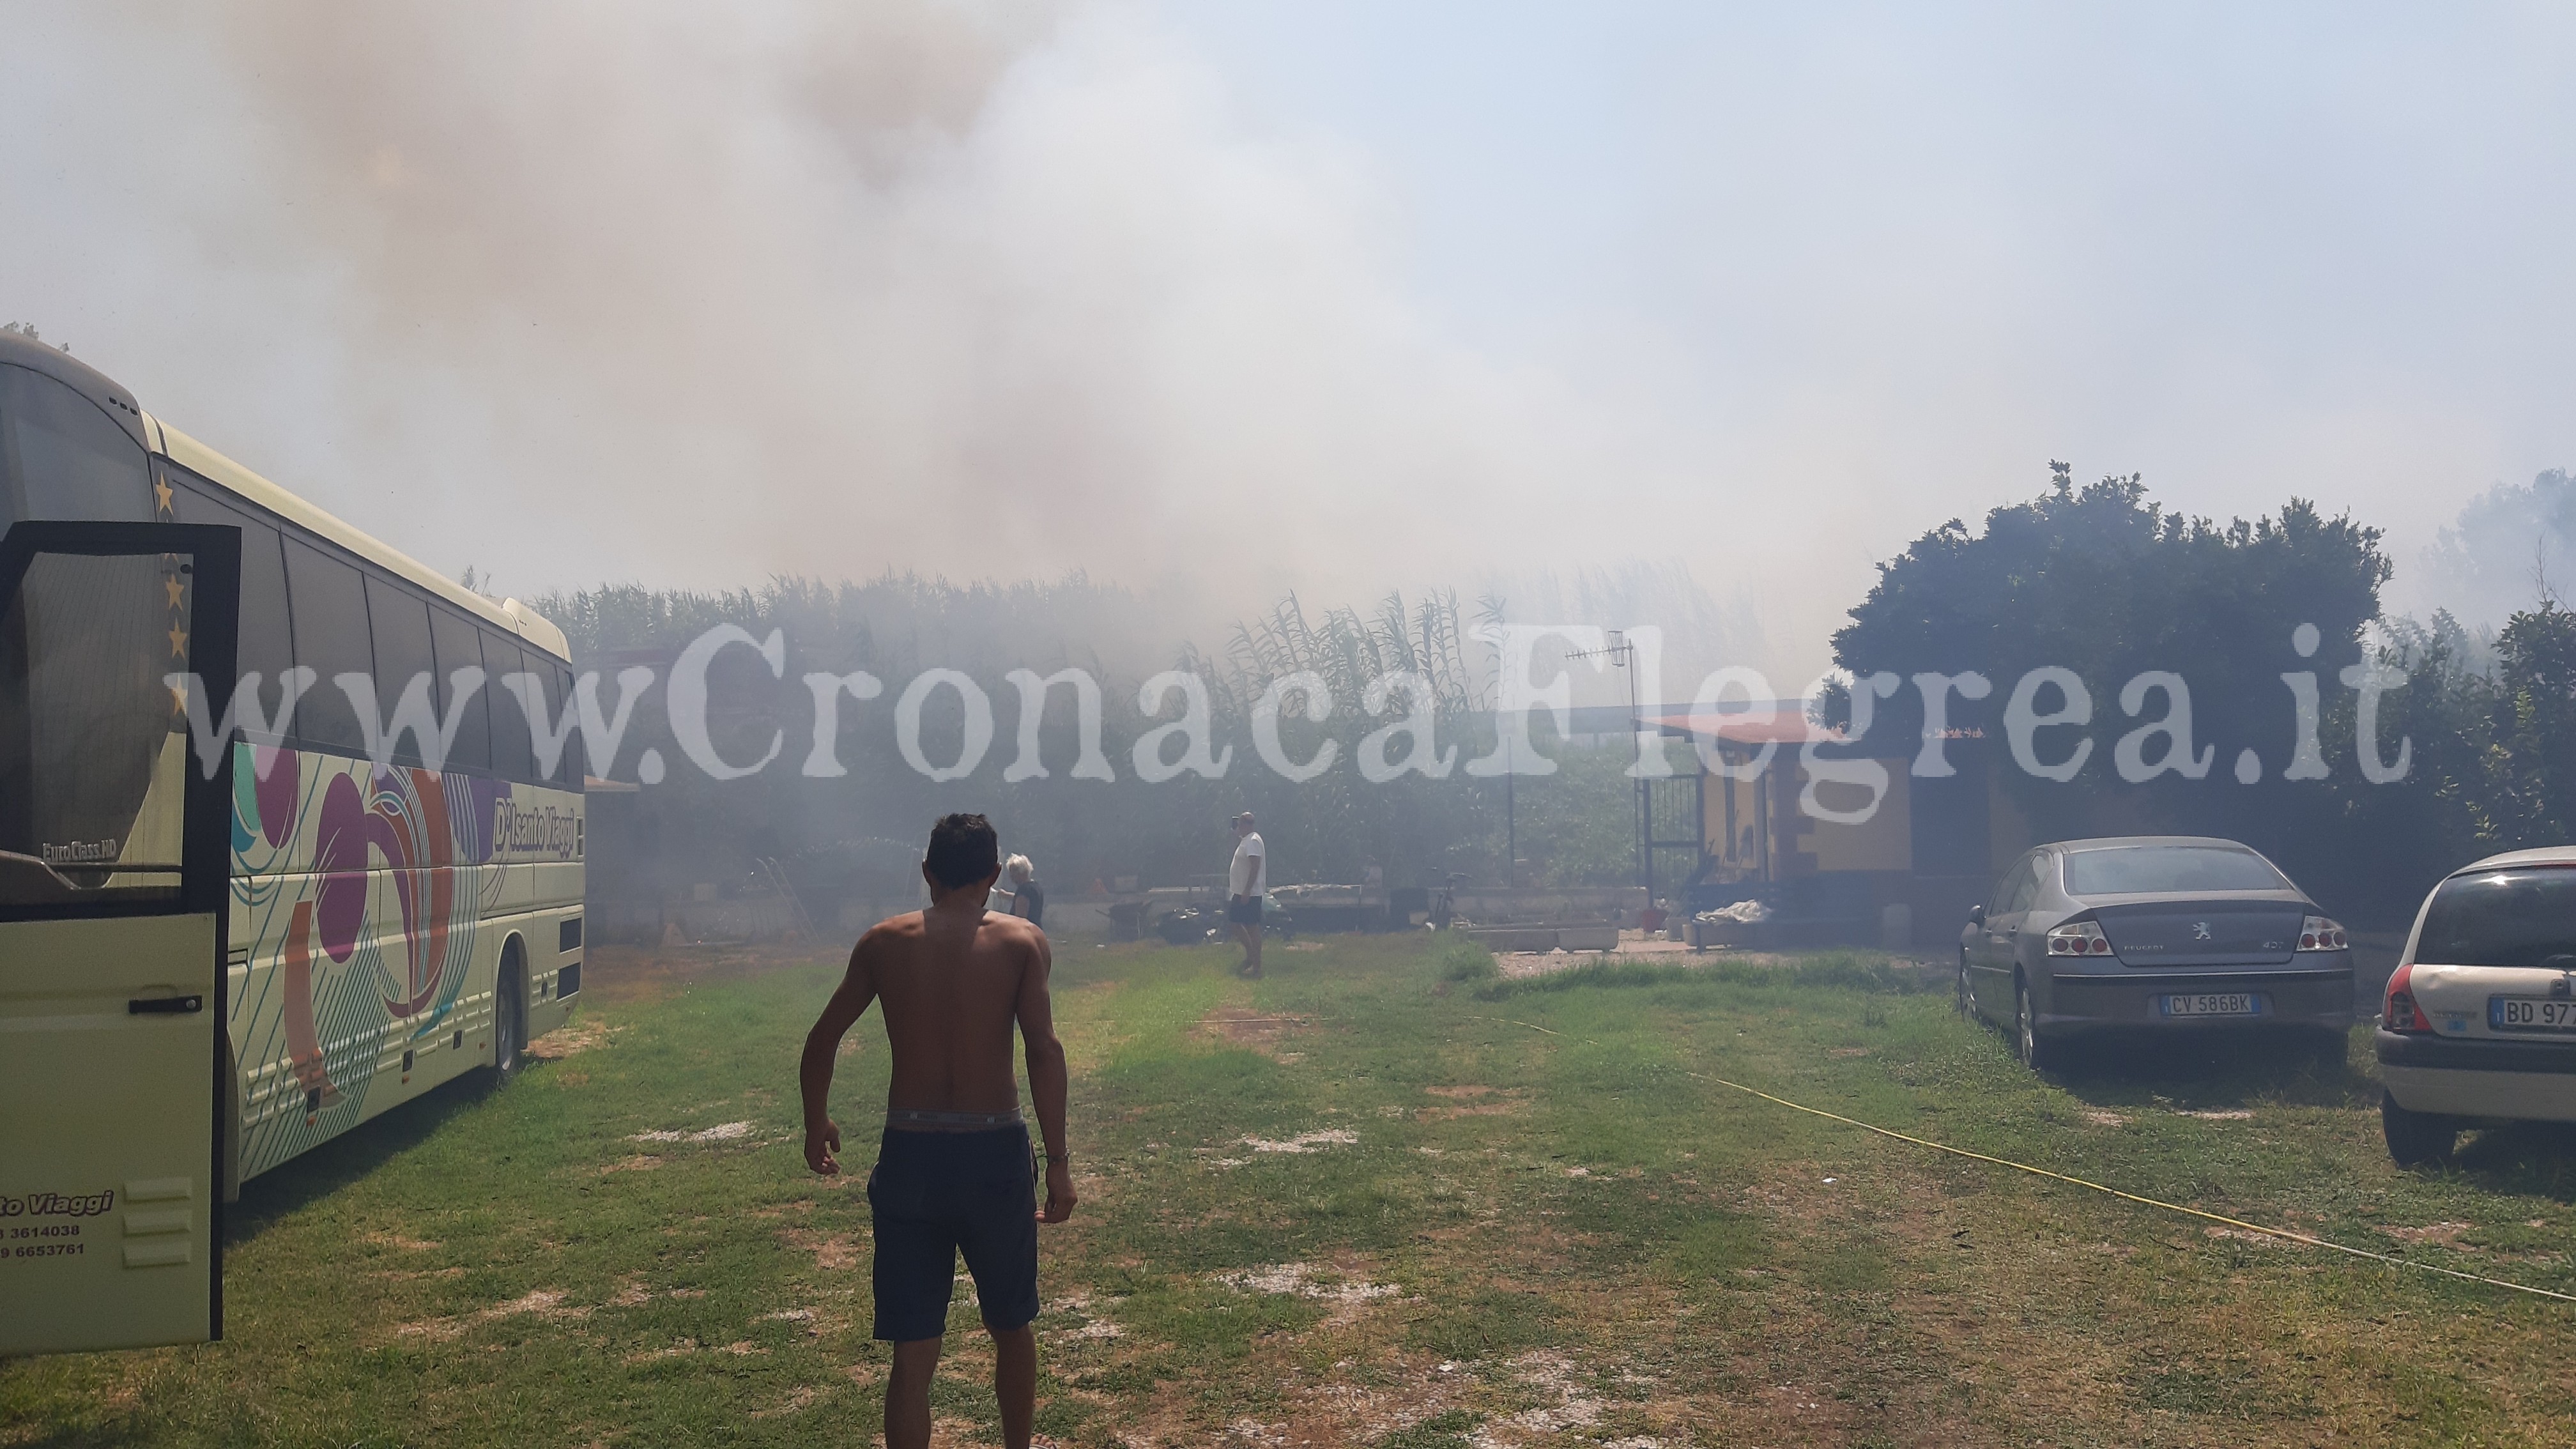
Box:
[799,815,1074,1449]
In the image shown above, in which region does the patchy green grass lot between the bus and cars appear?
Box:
[0,939,2576,1449]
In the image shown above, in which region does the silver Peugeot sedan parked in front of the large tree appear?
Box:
[1958,836,2352,1070]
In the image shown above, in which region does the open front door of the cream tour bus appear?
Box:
[0,521,240,1356]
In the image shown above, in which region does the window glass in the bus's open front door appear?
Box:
[0,555,188,908]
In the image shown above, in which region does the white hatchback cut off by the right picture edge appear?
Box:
[2375,846,2576,1163]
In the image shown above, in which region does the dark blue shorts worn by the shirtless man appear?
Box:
[868,1127,1038,1344]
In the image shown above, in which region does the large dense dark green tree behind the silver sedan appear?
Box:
[1834,464,2391,907]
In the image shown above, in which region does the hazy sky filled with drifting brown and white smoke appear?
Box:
[0,0,2576,686]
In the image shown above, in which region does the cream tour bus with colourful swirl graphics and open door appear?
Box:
[0,333,585,1356]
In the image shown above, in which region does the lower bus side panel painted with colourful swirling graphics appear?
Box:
[229,745,579,1178]
